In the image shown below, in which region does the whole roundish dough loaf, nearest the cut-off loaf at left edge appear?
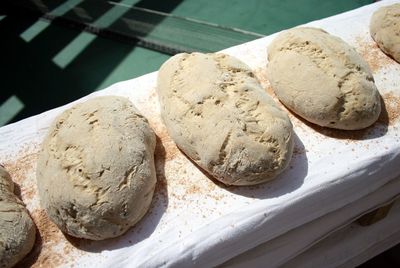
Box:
[37,96,156,240]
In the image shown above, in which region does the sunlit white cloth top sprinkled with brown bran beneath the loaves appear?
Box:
[0,1,400,267]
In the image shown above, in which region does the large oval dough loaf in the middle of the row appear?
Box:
[158,53,293,185]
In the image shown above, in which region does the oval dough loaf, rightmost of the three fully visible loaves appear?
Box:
[267,28,381,130]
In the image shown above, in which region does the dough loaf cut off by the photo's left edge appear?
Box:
[0,166,36,268]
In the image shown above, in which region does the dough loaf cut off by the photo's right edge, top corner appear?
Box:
[370,3,400,62]
